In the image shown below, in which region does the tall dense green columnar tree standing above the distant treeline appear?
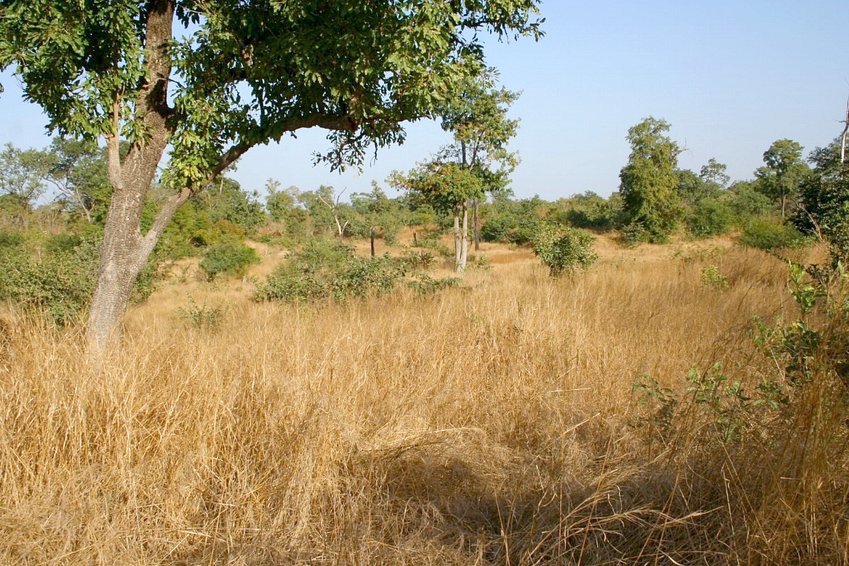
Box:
[619,117,682,242]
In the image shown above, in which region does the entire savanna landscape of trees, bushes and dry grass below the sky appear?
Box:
[0,0,849,565]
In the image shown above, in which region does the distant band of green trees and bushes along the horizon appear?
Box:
[0,118,849,322]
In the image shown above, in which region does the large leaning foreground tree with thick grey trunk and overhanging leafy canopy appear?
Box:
[0,0,541,352]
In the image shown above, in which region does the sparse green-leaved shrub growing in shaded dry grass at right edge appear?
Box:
[634,263,849,443]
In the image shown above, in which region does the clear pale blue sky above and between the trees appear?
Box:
[0,0,849,200]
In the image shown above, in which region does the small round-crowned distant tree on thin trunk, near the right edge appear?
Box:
[755,139,808,220]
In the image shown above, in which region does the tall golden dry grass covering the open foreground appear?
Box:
[0,242,849,564]
